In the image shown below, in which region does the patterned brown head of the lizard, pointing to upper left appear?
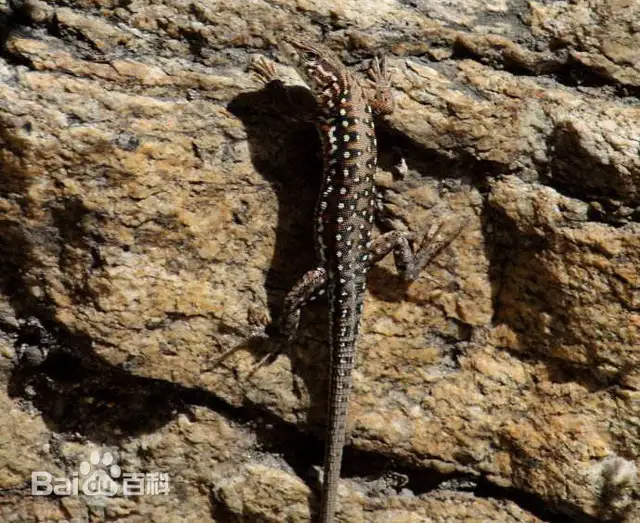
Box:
[279,36,345,96]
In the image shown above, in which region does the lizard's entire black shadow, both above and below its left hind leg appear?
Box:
[223,81,336,470]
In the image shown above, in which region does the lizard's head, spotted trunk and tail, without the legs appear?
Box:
[284,39,377,523]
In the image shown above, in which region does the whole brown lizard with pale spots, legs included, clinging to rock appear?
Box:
[252,37,450,523]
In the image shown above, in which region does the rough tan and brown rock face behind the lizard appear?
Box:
[0,0,640,523]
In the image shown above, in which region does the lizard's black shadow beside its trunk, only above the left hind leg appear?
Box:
[227,82,322,319]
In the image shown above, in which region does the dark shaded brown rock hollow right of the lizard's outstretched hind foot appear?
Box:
[484,194,623,392]
